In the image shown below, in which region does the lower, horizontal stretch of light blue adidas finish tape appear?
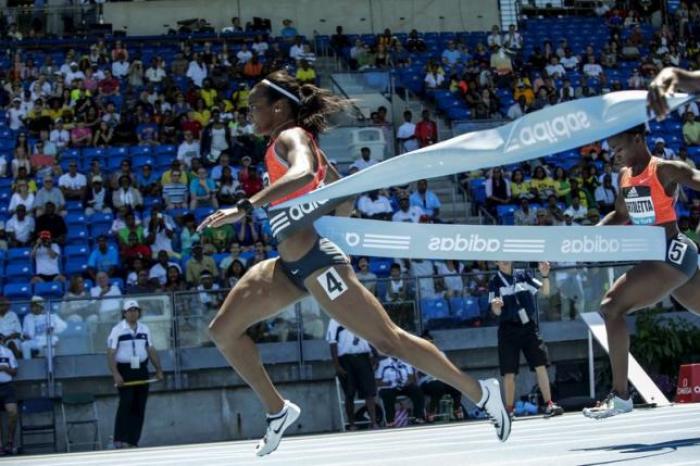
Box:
[314,217,666,262]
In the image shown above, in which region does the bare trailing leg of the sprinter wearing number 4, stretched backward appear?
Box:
[304,265,482,402]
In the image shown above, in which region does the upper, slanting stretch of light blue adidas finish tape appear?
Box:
[271,91,695,208]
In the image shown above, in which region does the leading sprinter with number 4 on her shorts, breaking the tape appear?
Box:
[199,71,510,456]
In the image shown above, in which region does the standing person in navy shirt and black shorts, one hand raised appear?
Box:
[489,261,564,416]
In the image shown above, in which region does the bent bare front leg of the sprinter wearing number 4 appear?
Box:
[209,259,305,413]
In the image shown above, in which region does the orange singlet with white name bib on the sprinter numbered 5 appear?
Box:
[620,157,676,225]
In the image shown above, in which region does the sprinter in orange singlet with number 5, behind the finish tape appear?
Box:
[583,121,700,419]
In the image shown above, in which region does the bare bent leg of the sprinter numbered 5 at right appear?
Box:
[600,262,687,398]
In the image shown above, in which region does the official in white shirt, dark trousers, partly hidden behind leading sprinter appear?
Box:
[326,319,378,430]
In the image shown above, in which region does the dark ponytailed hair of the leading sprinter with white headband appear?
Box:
[263,70,350,135]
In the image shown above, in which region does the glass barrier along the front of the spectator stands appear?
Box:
[9,264,668,384]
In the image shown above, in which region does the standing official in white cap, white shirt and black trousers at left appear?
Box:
[107,299,163,448]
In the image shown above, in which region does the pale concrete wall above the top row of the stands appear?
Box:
[104,0,499,37]
